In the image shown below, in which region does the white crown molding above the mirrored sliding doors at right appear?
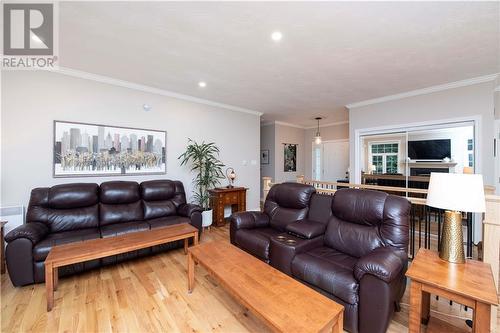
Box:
[346,73,498,109]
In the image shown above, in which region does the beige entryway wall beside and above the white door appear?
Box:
[304,123,349,179]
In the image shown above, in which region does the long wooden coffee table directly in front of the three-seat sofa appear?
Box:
[45,223,198,311]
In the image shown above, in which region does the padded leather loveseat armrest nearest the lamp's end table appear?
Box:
[354,246,408,283]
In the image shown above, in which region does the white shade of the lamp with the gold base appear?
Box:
[427,172,486,213]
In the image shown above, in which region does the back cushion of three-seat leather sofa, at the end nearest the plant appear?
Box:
[140,180,186,219]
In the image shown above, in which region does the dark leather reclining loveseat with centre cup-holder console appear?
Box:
[230,183,410,333]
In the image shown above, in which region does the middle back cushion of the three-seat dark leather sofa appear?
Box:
[99,181,144,225]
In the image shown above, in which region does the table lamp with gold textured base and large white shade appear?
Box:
[427,172,486,263]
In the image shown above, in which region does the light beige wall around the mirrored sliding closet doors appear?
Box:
[349,82,495,184]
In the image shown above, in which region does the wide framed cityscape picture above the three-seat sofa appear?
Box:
[53,120,167,177]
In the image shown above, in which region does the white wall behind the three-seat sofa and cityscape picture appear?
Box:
[0,71,260,228]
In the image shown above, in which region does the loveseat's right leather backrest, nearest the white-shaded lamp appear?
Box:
[325,189,410,258]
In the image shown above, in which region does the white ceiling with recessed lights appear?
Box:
[59,2,500,126]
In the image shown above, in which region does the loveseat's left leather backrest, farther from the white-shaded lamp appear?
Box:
[264,183,316,231]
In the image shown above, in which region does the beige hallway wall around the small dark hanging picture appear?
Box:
[273,124,305,183]
